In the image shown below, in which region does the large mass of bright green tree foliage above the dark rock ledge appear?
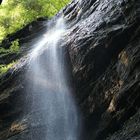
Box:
[0,0,69,42]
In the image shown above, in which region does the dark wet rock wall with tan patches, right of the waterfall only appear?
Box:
[64,0,140,140]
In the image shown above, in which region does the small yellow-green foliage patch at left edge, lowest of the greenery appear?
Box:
[0,61,16,76]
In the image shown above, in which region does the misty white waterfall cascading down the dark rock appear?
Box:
[28,18,79,140]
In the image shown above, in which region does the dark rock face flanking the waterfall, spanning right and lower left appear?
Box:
[0,0,140,140]
